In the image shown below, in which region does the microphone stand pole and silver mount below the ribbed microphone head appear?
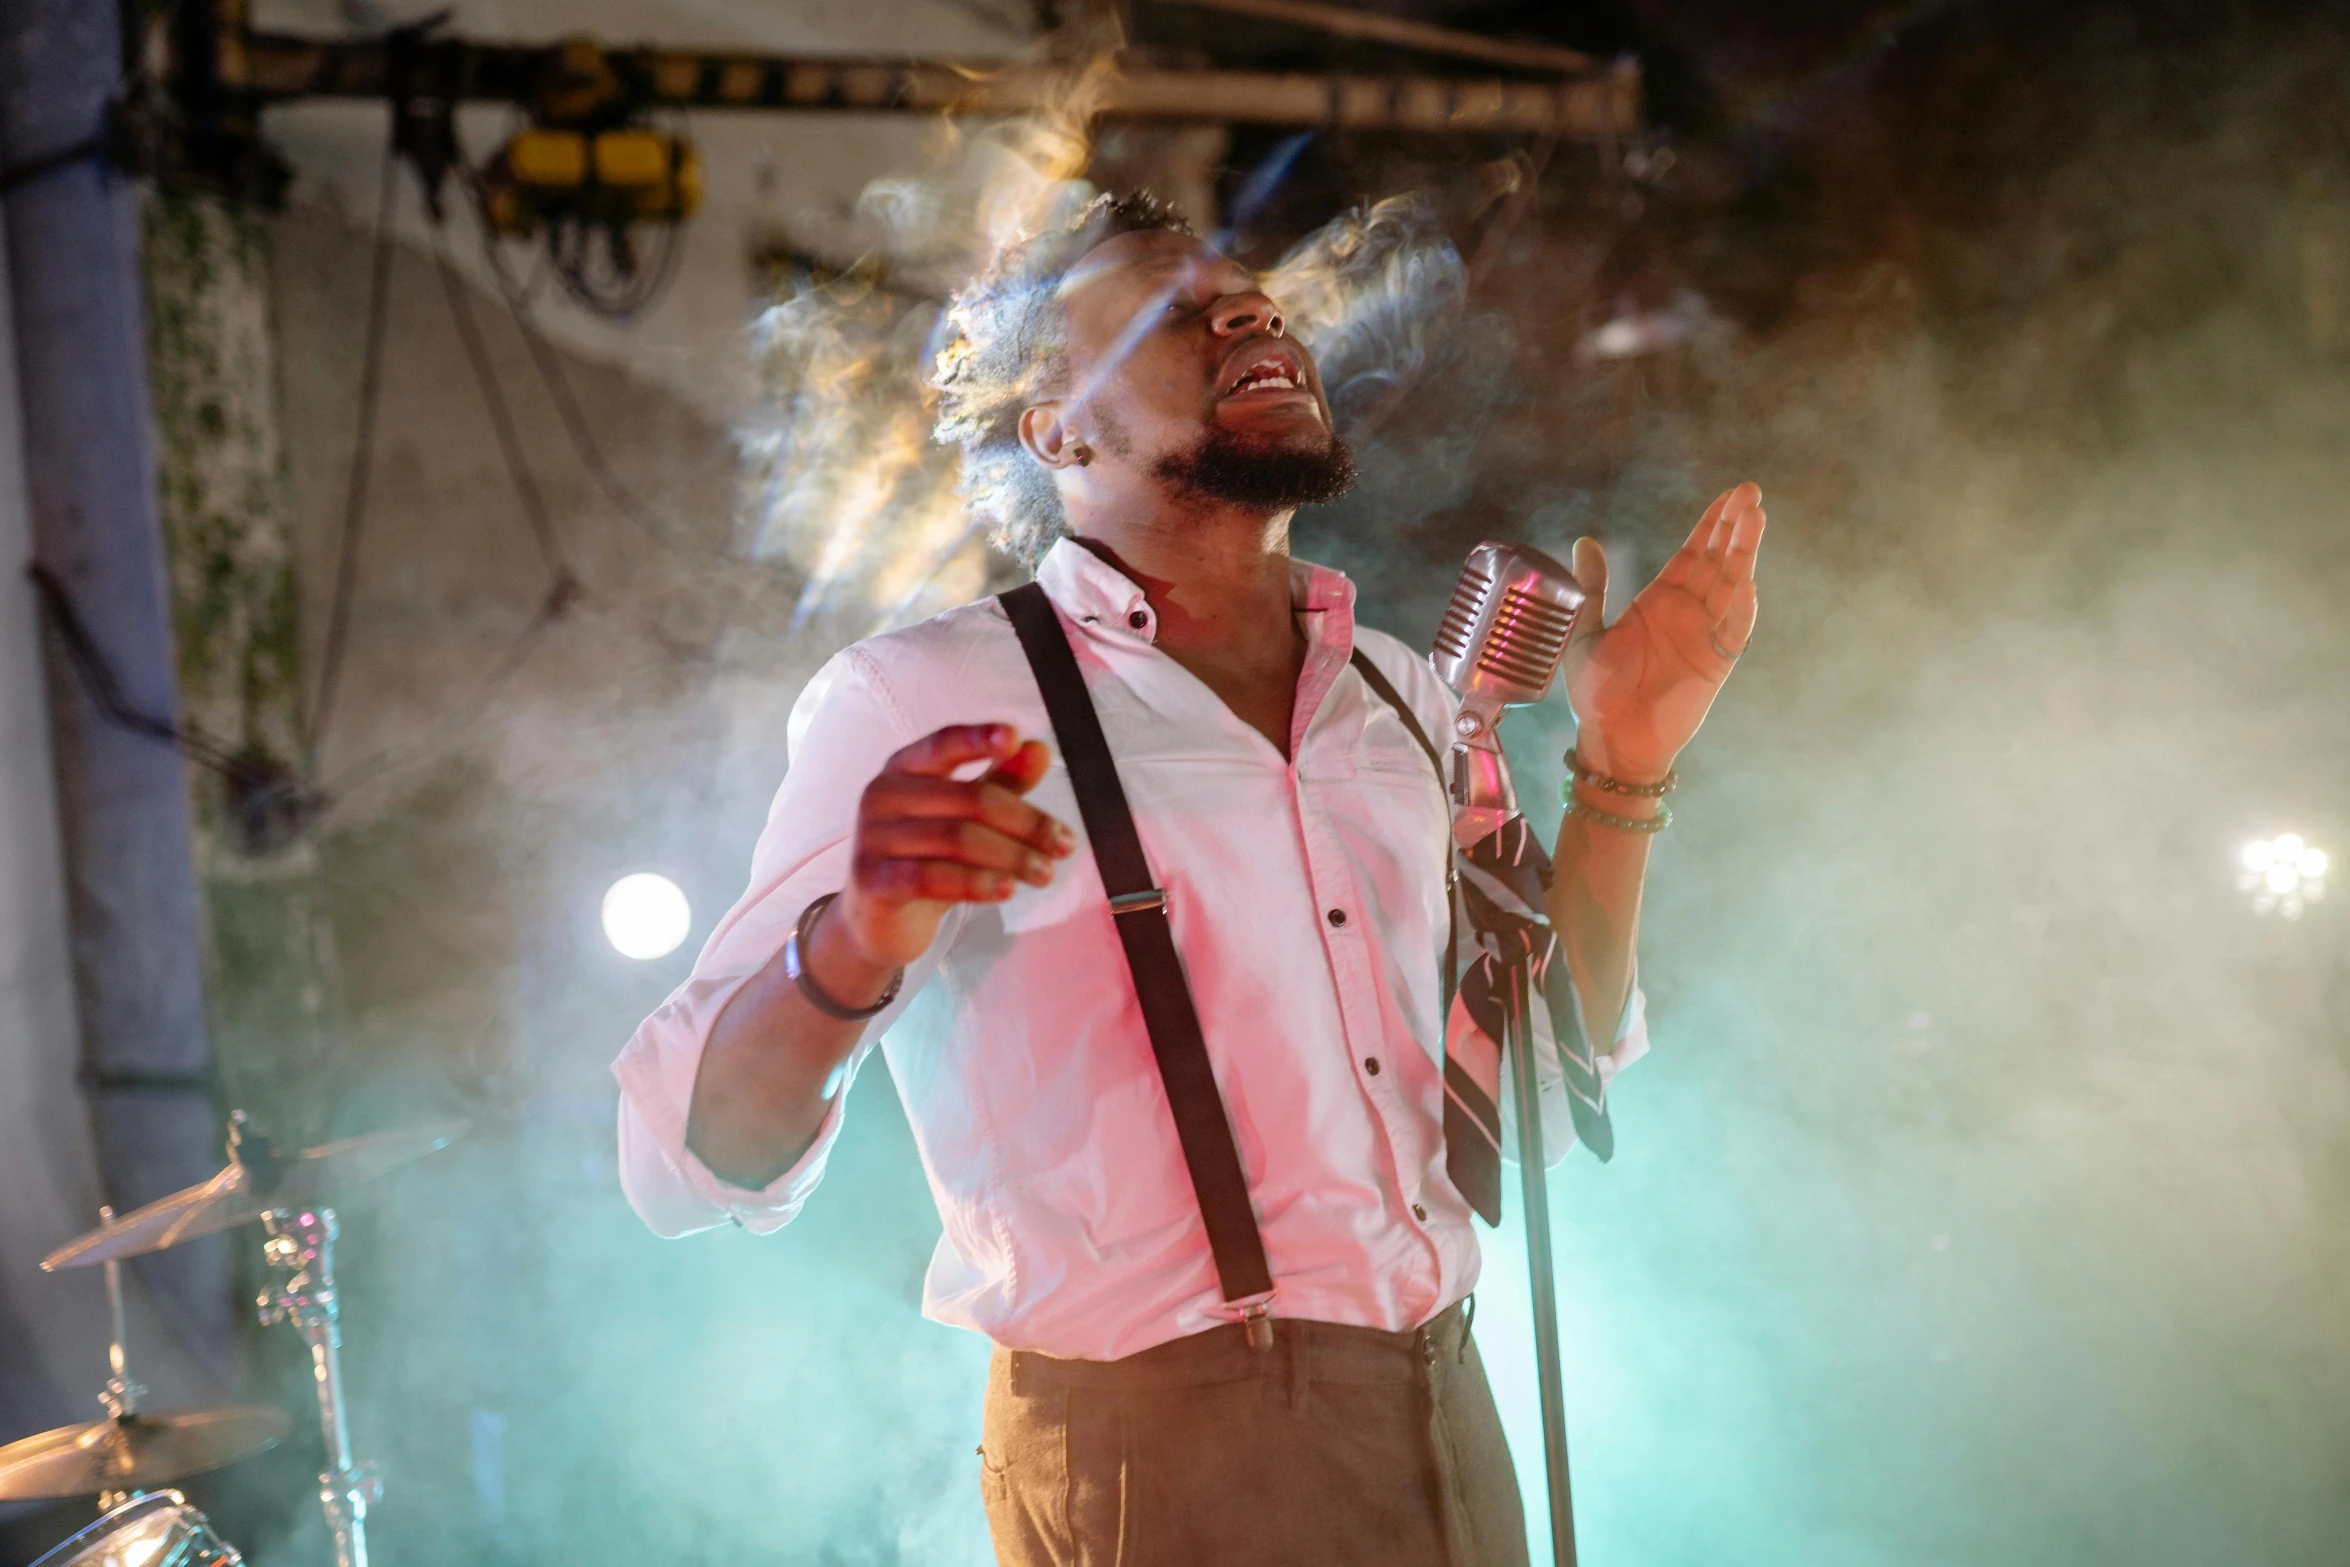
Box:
[1452,723,1582,1567]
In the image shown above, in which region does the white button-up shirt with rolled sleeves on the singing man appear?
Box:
[613,543,1647,1360]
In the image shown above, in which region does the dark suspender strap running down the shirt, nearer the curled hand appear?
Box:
[999,583,1274,1349]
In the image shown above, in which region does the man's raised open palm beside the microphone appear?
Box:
[1565,484,1765,780]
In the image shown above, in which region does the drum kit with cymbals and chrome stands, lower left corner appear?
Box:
[0,1111,468,1567]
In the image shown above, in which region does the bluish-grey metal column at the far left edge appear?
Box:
[0,0,235,1381]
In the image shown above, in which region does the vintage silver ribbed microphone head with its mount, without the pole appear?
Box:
[1429,540,1584,848]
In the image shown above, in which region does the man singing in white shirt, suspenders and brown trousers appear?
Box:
[616,197,1763,1567]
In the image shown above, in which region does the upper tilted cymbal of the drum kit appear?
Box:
[40,1121,472,1273]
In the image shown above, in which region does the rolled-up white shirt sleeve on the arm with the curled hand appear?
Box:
[611,648,935,1236]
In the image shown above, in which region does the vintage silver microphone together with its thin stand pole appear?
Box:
[1429,543,1584,1567]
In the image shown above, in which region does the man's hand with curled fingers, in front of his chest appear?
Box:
[818,724,1076,970]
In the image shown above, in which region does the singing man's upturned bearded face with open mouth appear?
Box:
[1038,230,1351,512]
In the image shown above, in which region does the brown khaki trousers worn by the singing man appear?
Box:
[980,1306,1525,1567]
